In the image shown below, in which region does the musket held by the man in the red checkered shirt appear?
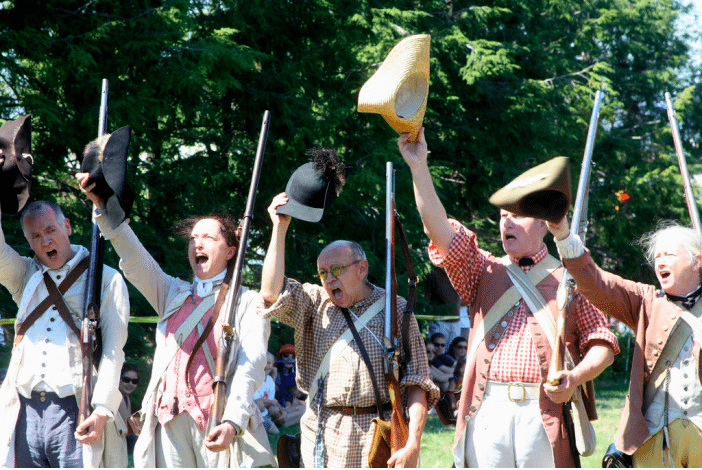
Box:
[547,90,602,385]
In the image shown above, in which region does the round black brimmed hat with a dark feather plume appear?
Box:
[276,149,346,222]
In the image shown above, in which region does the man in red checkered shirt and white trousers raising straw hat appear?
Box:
[398,129,619,467]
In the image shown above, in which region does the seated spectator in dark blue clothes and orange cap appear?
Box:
[275,344,306,427]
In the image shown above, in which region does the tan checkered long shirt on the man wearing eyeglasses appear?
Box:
[260,279,439,467]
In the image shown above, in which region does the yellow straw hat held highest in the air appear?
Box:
[358,34,431,140]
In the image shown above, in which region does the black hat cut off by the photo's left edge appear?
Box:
[0,114,34,214]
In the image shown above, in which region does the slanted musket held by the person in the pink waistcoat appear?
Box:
[208,111,270,429]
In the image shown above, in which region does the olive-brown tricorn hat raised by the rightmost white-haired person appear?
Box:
[490,157,571,223]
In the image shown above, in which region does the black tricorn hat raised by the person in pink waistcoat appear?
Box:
[80,126,134,228]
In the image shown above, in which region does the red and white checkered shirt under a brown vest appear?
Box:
[429,219,619,383]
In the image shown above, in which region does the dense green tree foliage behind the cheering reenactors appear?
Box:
[0,0,702,396]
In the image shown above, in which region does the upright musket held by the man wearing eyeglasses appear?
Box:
[384,162,409,454]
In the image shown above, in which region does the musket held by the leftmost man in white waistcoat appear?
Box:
[78,79,108,423]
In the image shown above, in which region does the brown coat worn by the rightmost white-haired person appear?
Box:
[565,251,702,454]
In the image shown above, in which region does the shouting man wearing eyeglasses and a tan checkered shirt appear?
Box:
[261,193,438,467]
